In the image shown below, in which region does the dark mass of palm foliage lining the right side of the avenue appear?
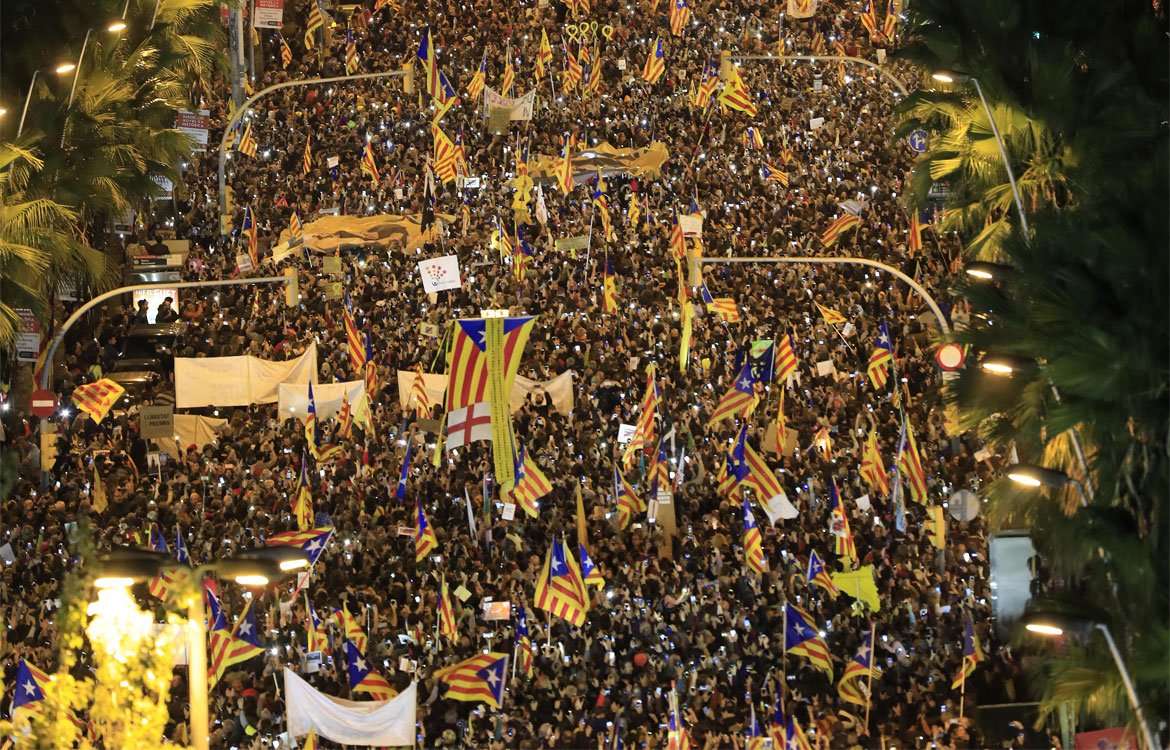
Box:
[902,0,1170,725]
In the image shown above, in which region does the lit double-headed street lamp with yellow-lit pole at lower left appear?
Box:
[94,546,309,750]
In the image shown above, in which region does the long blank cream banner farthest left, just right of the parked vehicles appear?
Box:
[174,342,317,408]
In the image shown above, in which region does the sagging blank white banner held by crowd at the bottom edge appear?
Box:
[284,669,418,748]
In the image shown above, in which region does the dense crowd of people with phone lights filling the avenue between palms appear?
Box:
[0,0,1023,749]
